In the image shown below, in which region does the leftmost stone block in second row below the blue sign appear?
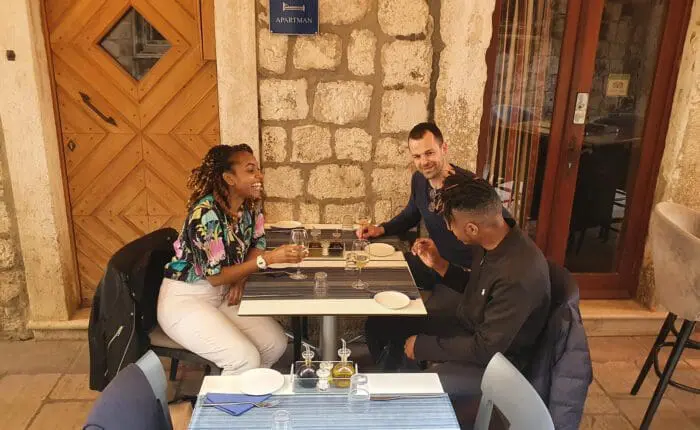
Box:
[260,79,309,121]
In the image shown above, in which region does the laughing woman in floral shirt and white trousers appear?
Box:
[158,144,302,374]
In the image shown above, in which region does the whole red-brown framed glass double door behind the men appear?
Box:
[478,0,691,298]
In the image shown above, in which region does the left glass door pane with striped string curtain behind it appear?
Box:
[485,0,567,237]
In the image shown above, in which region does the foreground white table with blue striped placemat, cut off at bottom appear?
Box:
[189,373,460,430]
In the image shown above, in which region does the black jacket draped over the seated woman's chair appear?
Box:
[88,228,177,391]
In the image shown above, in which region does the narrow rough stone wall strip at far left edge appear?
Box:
[0,117,29,339]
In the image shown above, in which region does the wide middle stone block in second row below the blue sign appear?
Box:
[313,81,373,125]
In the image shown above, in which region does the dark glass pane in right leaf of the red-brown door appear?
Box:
[566,0,666,272]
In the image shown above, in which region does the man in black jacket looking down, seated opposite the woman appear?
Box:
[374,174,550,395]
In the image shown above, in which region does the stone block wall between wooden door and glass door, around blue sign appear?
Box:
[257,0,434,223]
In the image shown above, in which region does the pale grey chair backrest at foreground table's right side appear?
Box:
[474,352,554,430]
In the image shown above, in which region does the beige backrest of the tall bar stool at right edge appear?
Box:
[650,202,700,321]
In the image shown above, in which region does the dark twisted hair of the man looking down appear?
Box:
[440,172,503,223]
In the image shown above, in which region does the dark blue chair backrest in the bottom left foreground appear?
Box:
[83,363,172,430]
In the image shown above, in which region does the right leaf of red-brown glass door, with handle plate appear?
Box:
[543,0,689,298]
